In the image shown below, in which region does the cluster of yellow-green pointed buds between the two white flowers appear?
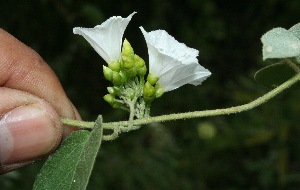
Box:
[103,39,147,110]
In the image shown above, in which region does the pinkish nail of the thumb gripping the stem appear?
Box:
[0,104,60,164]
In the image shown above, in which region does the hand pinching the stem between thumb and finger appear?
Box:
[0,29,80,174]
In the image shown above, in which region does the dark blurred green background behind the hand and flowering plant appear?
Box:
[0,0,300,190]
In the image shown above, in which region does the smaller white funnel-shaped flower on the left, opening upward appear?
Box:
[73,12,136,64]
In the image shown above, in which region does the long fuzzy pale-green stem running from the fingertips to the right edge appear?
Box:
[62,73,300,129]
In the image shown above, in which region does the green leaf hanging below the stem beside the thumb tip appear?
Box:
[33,116,103,190]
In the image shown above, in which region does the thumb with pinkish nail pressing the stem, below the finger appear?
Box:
[0,88,63,174]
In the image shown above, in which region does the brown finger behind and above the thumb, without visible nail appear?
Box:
[0,29,80,134]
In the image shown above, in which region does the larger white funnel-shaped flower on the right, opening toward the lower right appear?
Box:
[140,27,211,92]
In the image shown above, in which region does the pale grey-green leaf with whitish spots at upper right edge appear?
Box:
[261,26,300,60]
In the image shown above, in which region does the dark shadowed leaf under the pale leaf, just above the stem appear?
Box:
[254,62,299,89]
